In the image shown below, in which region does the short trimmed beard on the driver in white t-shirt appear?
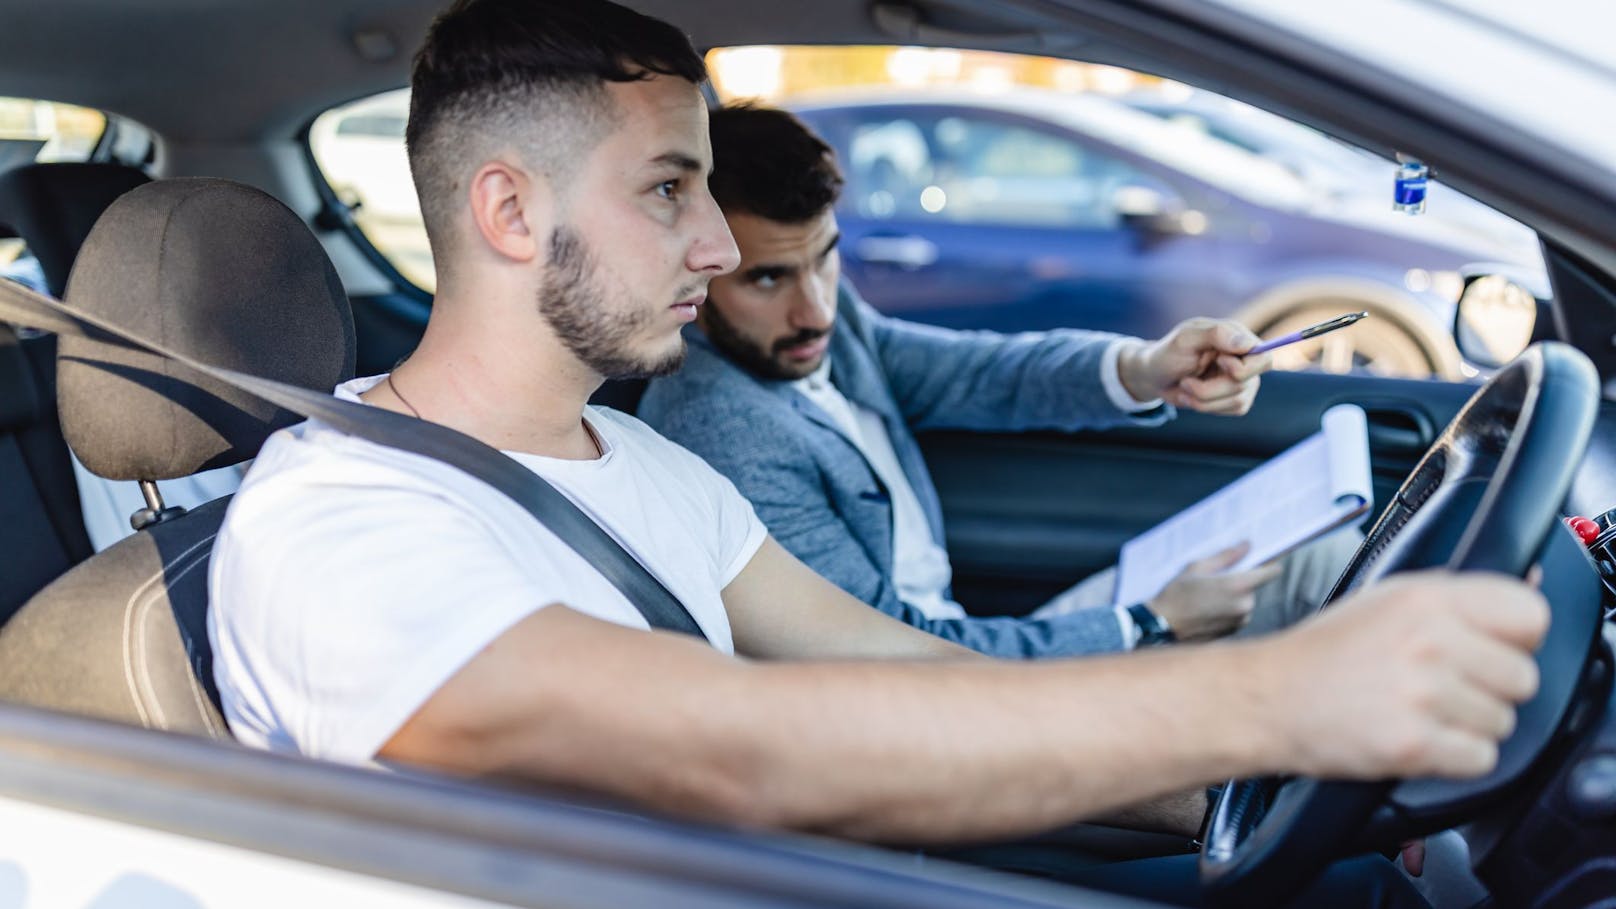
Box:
[538,226,685,378]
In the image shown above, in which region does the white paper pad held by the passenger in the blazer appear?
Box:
[1115,404,1374,605]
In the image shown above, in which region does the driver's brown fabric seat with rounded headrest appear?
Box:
[0,178,354,738]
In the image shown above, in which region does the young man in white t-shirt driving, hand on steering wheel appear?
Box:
[208,0,1547,904]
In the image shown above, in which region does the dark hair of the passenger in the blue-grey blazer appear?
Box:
[708,104,842,225]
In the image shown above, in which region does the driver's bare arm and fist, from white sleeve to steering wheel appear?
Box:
[381,574,1548,843]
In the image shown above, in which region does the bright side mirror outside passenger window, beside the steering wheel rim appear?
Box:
[1453,265,1553,369]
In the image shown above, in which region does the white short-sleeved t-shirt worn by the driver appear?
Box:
[208,377,766,762]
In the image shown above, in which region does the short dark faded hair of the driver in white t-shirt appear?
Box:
[404,0,706,247]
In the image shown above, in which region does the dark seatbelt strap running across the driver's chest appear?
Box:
[0,280,706,641]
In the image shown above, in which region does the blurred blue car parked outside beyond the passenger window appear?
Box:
[792,91,1544,378]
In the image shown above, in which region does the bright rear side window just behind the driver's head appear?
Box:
[309,89,436,293]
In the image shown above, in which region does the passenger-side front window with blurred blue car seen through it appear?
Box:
[708,47,1543,380]
